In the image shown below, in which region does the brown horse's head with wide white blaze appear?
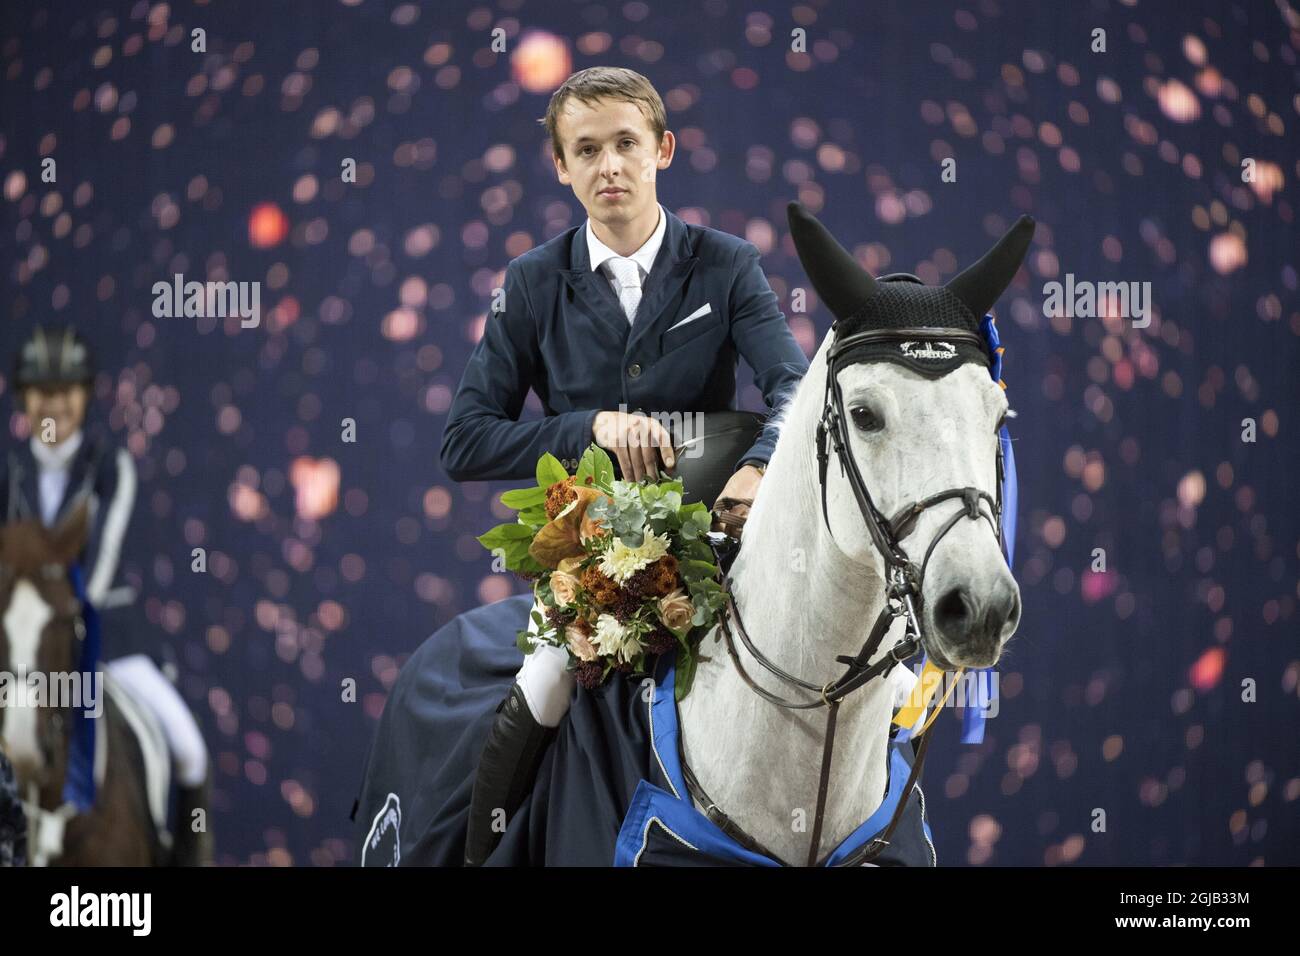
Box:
[0,501,87,792]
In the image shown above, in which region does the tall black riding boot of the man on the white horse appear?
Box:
[465,684,555,866]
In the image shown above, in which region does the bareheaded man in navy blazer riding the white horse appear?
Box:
[431,68,807,864]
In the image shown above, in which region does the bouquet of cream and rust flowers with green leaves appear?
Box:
[478,444,725,700]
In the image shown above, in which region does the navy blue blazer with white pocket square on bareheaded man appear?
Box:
[442,209,809,481]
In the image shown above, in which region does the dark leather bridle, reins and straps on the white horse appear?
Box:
[681,320,1005,866]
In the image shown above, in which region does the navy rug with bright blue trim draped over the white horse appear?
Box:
[354,594,935,866]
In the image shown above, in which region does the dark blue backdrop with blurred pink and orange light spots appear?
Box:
[0,0,1300,865]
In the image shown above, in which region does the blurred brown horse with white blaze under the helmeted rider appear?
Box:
[0,501,211,866]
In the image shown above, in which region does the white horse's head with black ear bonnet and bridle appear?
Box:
[789,203,1034,669]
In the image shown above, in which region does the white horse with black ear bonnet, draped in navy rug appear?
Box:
[358,204,1032,865]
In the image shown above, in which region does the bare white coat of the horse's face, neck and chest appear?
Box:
[679,211,1032,861]
